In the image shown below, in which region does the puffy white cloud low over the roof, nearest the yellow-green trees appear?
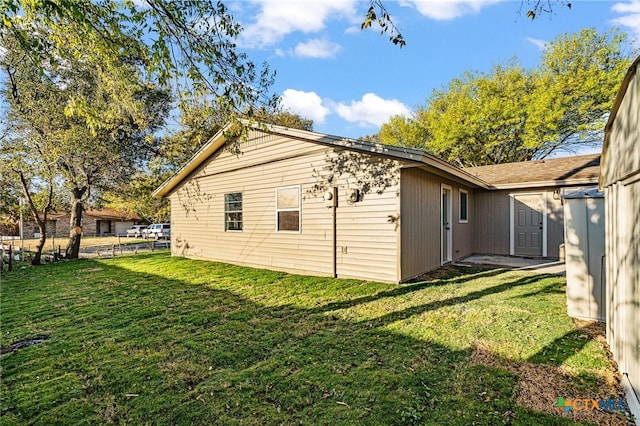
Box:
[336,93,411,127]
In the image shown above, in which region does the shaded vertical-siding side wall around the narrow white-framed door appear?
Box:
[400,168,475,281]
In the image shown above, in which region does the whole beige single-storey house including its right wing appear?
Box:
[154,121,598,282]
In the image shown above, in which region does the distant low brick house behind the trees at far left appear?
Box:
[24,208,143,238]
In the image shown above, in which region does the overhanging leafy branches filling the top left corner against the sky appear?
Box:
[0,0,277,127]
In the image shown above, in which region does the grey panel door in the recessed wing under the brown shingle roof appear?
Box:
[513,194,543,256]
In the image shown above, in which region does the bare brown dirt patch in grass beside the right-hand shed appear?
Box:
[469,320,633,426]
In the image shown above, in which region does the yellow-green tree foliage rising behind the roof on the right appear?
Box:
[380,29,629,166]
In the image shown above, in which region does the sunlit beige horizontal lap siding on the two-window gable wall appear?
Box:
[170,132,397,282]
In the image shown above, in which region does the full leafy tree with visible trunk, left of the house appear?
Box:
[2,28,169,258]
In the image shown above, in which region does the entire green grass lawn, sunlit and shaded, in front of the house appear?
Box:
[0,252,621,425]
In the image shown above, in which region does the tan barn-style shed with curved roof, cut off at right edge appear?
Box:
[600,57,640,415]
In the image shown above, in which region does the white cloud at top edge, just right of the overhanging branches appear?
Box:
[240,0,357,47]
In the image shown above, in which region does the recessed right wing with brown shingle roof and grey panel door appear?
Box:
[465,154,600,258]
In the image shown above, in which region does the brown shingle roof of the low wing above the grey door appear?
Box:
[464,154,600,189]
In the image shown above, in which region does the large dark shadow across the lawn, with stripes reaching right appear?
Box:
[0,257,584,425]
